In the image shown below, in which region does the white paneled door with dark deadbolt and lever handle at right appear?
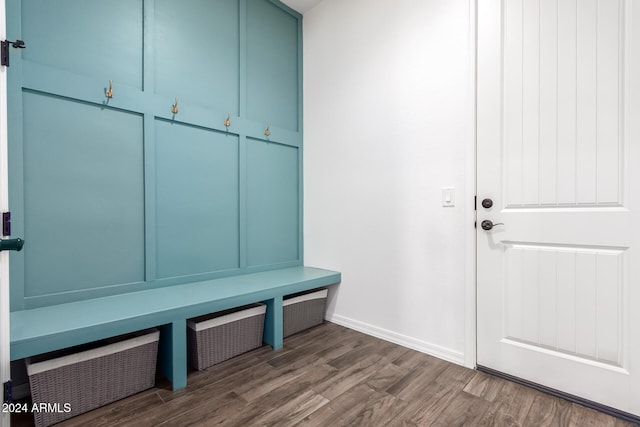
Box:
[477,0,640,415]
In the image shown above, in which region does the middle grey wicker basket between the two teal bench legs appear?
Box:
[187,303,267,370]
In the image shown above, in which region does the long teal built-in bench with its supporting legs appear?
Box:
[11,267,341,390]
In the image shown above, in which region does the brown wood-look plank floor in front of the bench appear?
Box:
[12,323,633,427]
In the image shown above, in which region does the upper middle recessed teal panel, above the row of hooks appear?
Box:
[153,0,240,116]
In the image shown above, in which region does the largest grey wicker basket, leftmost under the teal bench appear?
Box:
[26,329,160,427]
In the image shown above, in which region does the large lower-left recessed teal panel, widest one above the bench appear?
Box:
[22,92,144,298]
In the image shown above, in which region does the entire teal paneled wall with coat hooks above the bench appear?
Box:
[7,0,302,310]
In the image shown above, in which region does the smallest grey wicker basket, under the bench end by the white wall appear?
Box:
[282,289,327,337]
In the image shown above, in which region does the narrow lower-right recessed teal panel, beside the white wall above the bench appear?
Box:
[247,139,299,266]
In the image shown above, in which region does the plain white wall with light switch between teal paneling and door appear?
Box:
[303,0,474,364]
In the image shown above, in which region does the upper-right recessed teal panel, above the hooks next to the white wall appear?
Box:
[247,0,299,130]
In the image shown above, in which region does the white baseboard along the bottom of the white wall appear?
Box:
[327,314,464,366]
